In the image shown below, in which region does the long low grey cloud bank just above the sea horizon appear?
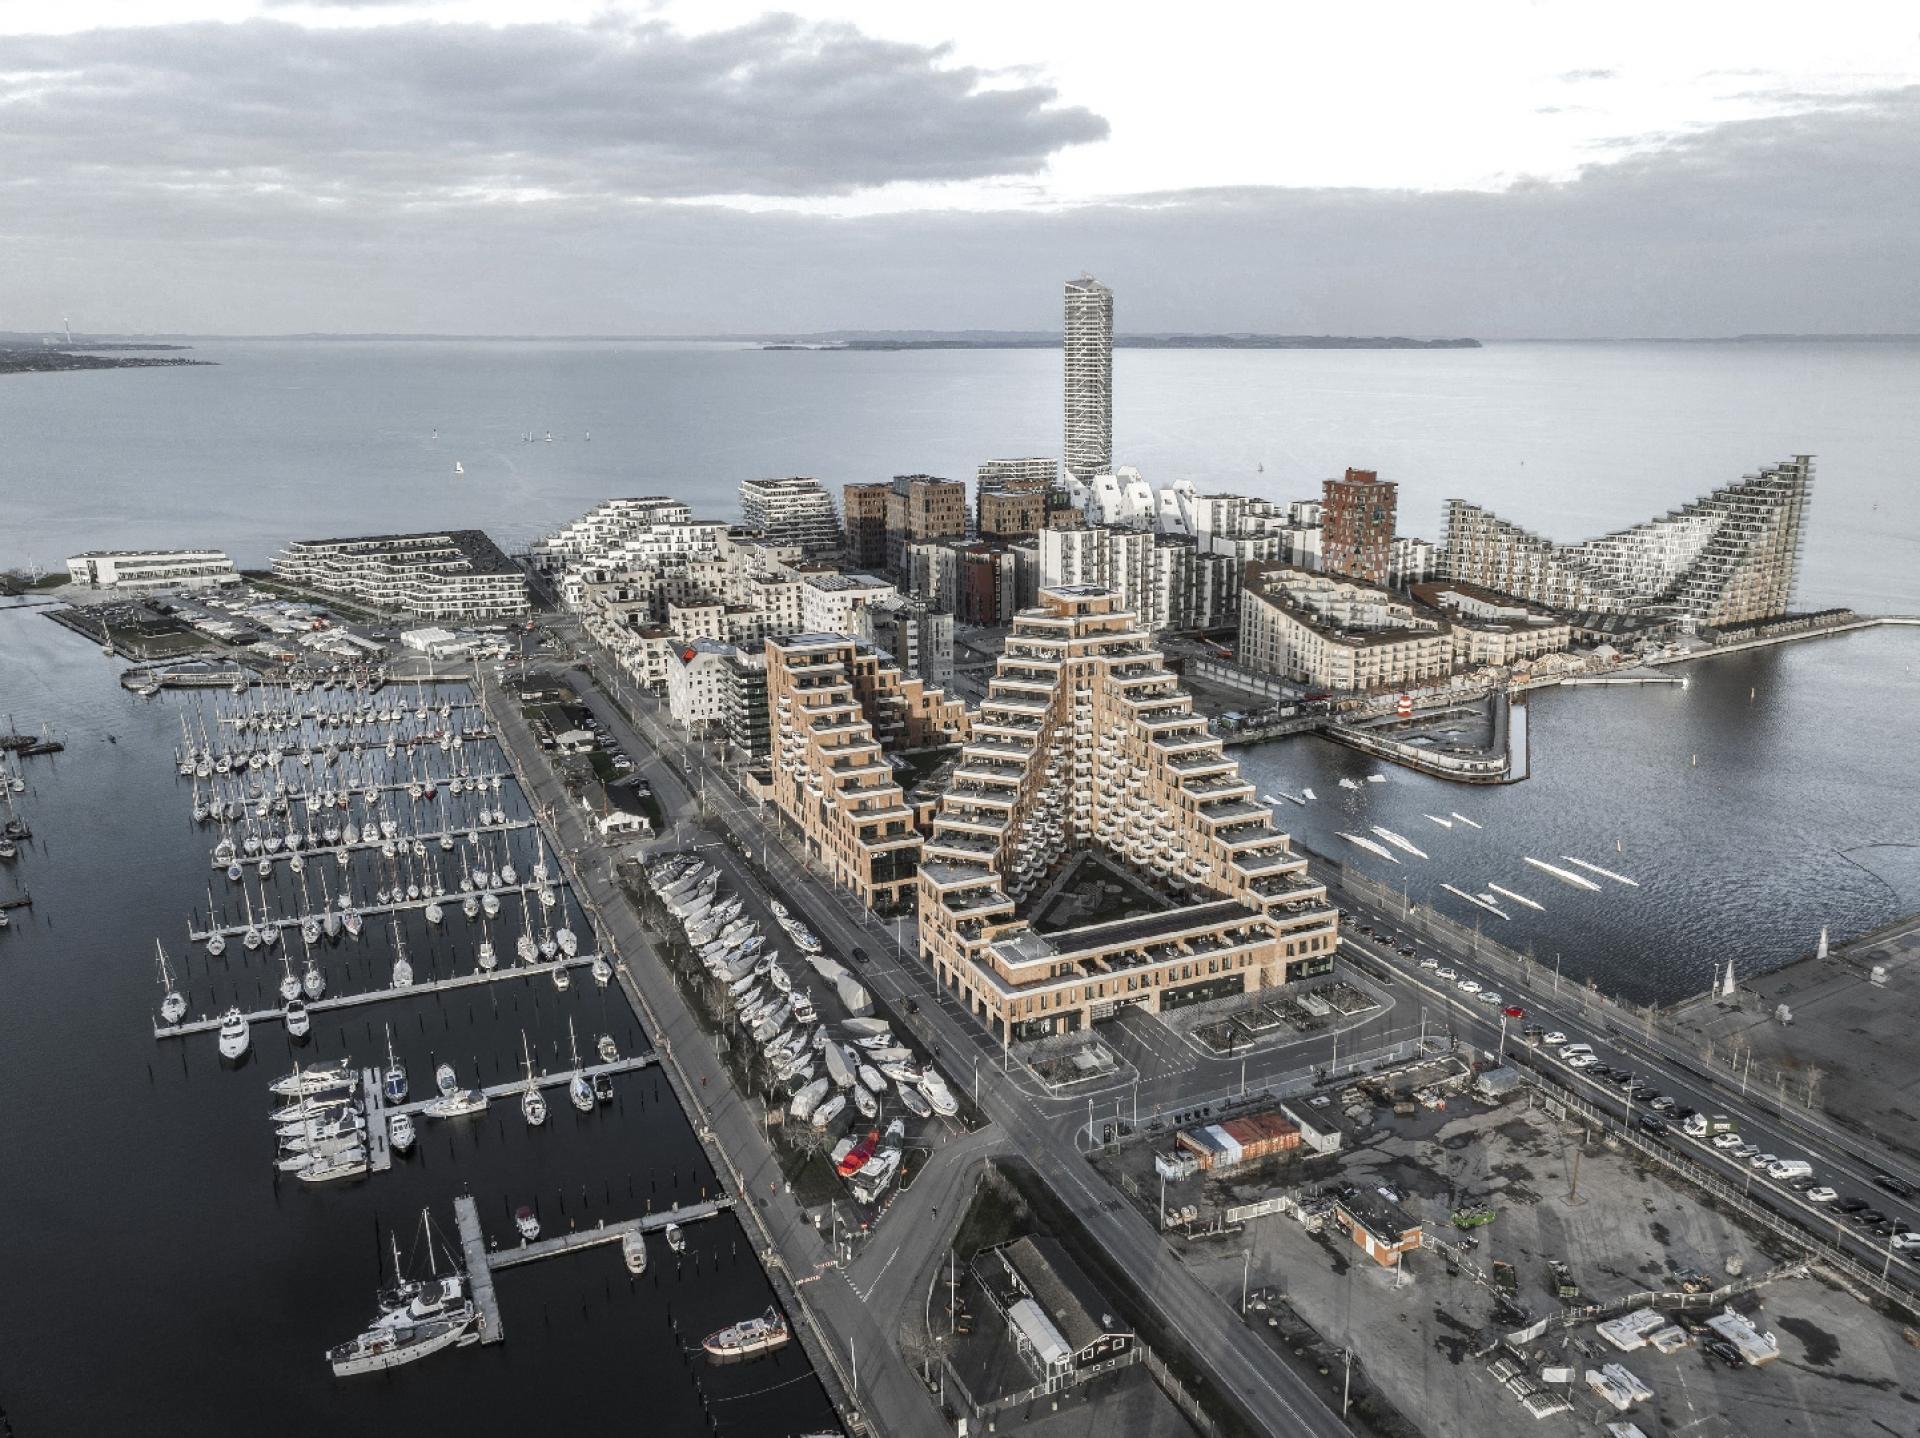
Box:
[0,86,1920,338]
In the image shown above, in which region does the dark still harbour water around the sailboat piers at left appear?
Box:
[0,609,831,1438]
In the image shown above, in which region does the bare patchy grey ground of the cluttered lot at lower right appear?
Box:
[1146,1100,1920,1438]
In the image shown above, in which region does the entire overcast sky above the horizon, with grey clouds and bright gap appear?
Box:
[0,0,1920,338]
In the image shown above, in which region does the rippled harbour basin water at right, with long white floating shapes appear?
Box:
[1238,628,1920,1002]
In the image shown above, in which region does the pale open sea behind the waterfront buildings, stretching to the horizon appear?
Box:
[0,340,1920,612]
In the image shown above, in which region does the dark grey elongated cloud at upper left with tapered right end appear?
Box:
[0,15,1106,204]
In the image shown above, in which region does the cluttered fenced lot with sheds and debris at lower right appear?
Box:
[1098,1056,1920,1438]
